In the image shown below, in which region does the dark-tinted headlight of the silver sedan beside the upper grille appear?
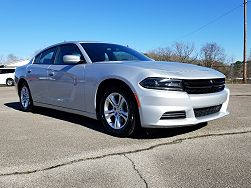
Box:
[139,77,183,91]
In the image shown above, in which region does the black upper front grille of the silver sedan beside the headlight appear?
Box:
[183,78,225,94]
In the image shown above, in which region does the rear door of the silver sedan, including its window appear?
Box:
[27,47,57,104]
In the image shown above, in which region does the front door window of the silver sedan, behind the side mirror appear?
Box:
[55,44,84,64]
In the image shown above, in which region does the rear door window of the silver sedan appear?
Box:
[34,48,57,64]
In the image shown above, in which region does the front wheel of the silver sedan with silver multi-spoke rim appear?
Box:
[100,87,137,137]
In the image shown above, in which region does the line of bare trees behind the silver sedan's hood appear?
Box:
[146,42,251,79]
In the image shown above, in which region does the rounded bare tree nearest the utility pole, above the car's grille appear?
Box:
[200,42,226,67]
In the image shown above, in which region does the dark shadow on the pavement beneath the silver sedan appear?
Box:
[4,102,207,139]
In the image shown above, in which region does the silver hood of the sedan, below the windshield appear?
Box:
[119,61,225,79]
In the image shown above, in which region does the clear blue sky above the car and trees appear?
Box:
[0,0,251,60]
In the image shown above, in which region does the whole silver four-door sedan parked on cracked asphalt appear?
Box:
[15,41,229,137]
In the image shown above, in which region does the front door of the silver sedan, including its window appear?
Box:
[48,44,85,111]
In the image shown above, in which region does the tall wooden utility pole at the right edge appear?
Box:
[243,0,248,83]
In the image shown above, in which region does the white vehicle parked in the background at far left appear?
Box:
[0,68,15,86]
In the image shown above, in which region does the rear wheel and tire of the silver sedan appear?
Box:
[19,83,33,112]
